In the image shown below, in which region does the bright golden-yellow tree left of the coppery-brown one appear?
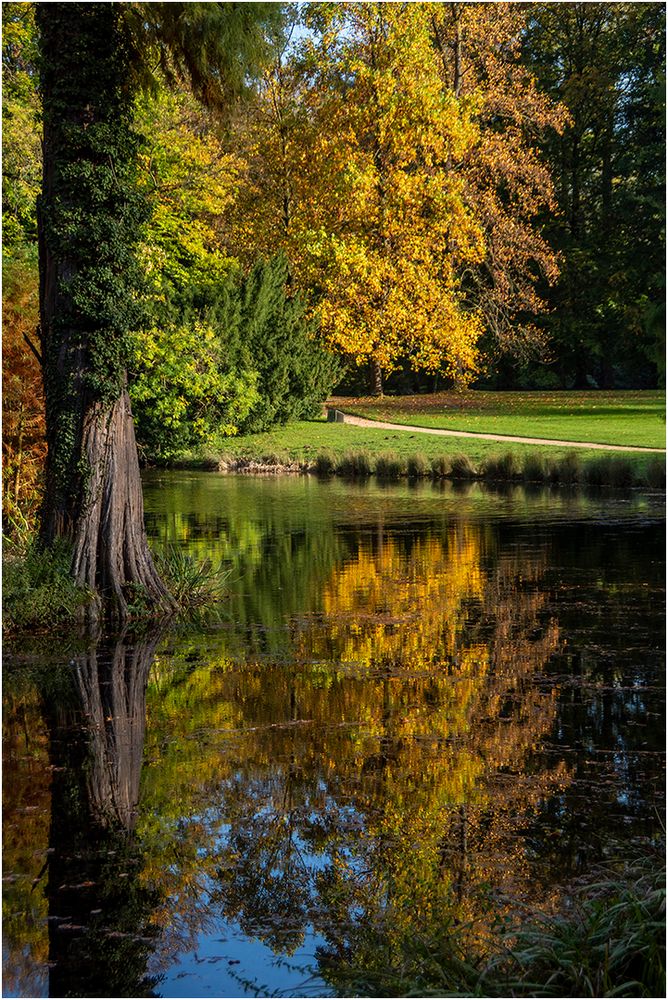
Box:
[305,3,484,391]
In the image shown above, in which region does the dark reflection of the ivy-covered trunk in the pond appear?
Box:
[45,633,160,997]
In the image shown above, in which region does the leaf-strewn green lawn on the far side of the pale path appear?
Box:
[331,390,666,448]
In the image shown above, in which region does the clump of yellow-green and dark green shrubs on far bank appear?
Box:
[130,256,340,461]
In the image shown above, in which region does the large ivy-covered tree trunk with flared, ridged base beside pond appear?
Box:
[37,3,170,620]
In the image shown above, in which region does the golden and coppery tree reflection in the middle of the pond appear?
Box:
[207,525,569,965]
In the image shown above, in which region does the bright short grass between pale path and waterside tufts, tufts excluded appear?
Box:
[211,418,653,469]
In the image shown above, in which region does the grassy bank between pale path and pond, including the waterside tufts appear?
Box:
[204,419,665,489]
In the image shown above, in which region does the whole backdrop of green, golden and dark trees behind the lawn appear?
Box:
[3,3,665,536]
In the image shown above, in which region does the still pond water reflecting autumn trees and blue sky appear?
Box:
[3,473,665,997]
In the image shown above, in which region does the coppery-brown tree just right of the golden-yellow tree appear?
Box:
[429,3,568,369]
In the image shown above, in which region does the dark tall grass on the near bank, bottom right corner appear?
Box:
[321,849,666,997]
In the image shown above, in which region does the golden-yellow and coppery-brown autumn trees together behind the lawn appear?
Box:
[230,3,564,388]
